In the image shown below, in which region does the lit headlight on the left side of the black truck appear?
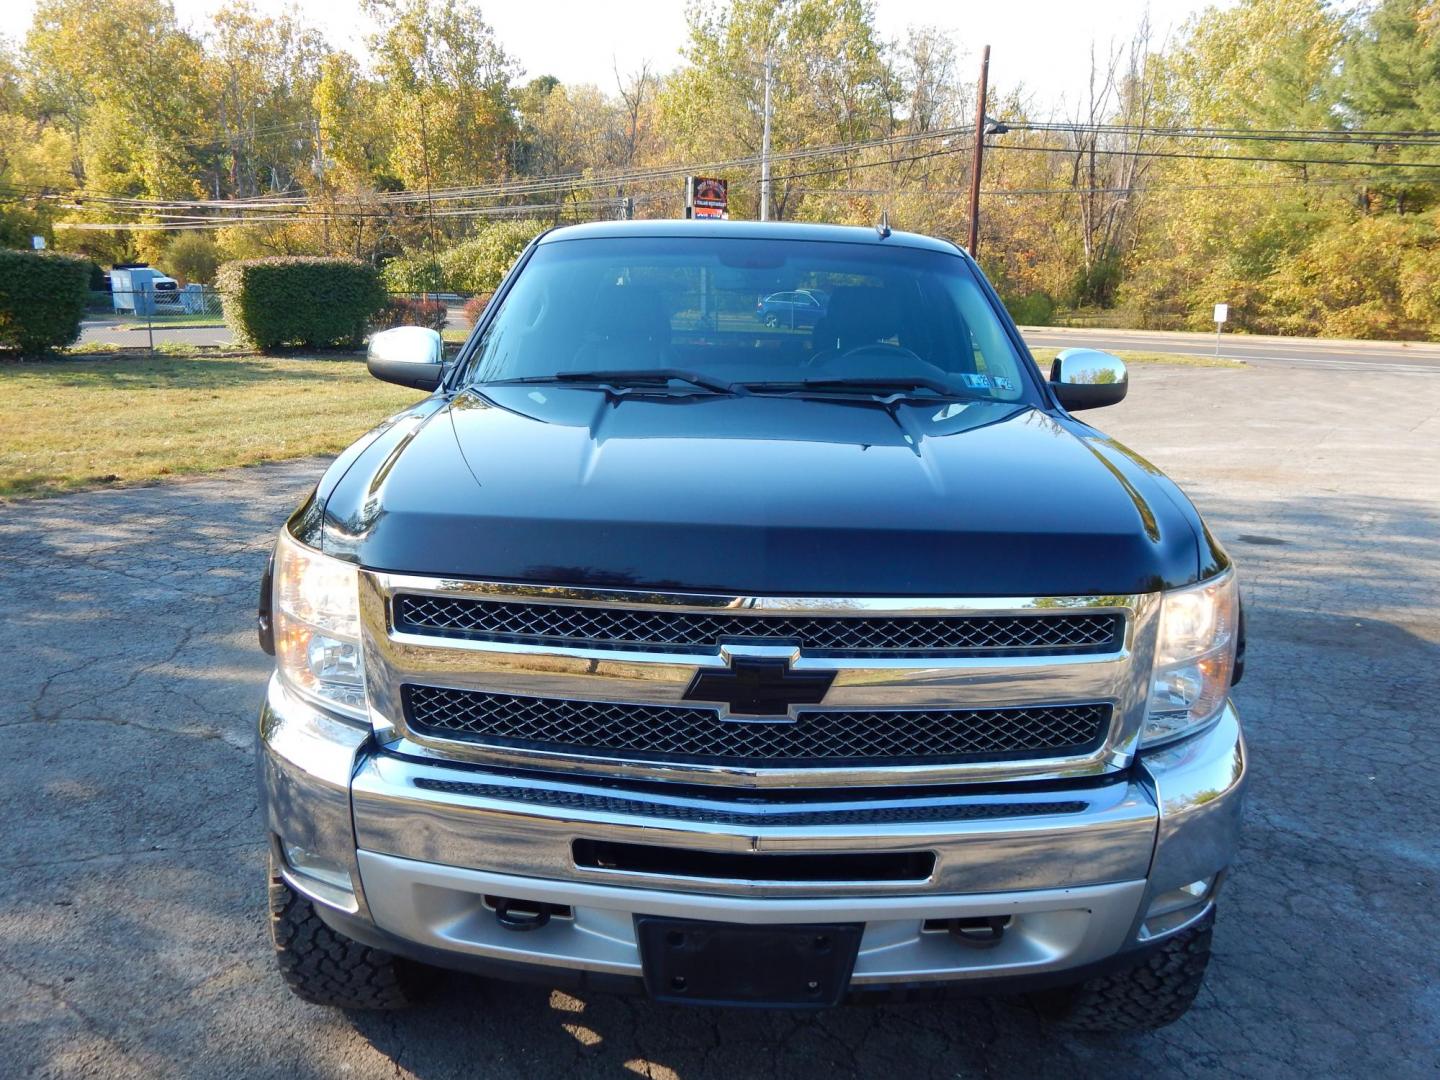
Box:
[274,528,366,720]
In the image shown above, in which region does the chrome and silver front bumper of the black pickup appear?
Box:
[261,681,1246,989]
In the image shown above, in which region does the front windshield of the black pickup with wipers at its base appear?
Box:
[464,236,1035,403]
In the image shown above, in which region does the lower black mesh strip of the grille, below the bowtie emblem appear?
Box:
[405,685,1110,768]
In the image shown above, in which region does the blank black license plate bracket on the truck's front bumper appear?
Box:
[635,914,865,1008]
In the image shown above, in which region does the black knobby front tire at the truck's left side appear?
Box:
[269,858,419,1009]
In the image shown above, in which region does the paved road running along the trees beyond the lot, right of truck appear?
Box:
[1021,327,1440,374]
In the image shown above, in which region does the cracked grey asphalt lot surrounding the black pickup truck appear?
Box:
[0,363,1440,1080]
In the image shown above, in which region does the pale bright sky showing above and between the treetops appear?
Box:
[0,0,1227,112]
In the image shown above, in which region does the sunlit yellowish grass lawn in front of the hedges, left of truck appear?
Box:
[0,356,423,498]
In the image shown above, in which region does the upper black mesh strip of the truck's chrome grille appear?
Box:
[395,593,1125,655]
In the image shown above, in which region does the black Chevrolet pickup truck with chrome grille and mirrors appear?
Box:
[258,222,1246,1030]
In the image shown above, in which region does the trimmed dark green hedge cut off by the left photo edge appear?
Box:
[0,249,91,356]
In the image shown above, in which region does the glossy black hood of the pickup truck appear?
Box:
[321,384,1224,596]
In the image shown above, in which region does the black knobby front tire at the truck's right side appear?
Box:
[1032,917,1214,1031]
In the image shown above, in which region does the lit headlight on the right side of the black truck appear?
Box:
[1140,570,1240,749]
